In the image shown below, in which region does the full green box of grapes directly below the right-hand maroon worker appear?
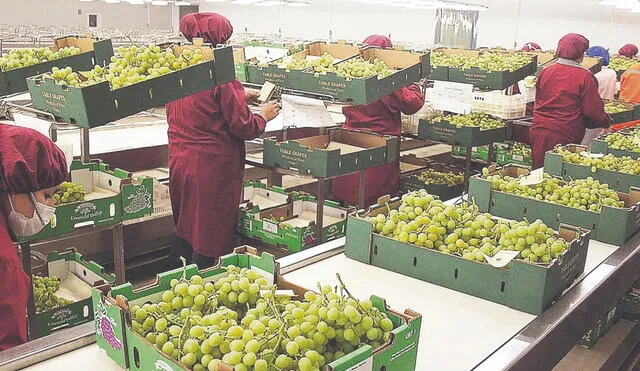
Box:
[544,144,640,192]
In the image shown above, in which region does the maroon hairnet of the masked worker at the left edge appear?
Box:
[0,124,67,194]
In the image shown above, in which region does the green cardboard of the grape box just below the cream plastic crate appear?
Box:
[418,120,511,147]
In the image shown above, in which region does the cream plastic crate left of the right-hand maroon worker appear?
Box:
[471,91,527,120]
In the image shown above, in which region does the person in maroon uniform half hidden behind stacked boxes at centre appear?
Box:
[333,35,424,206]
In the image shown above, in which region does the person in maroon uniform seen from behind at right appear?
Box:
[530,34,611,169]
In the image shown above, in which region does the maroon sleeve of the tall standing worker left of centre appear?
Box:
[218,80,267,140]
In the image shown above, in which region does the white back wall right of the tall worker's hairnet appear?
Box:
[200,0,640,51]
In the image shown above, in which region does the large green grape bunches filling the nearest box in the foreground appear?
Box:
[131,266,393,371]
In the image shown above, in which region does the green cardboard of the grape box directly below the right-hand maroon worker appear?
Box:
[544,144,640,192]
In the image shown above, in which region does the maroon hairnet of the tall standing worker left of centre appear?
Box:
[180,13,233,45]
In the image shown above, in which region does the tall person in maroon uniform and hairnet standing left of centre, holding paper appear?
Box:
[167,13,279,268]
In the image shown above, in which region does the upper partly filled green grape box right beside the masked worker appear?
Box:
[18,161,153,242]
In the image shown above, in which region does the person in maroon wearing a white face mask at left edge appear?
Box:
[0,124,67,351]
